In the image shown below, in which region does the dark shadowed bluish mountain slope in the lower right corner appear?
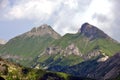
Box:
[62,53,120,80]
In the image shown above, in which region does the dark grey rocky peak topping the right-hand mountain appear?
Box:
[78,23,109,39]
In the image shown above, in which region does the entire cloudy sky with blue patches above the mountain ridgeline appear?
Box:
[0,0,120,42]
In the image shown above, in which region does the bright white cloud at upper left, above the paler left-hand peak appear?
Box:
[5,0,59,20]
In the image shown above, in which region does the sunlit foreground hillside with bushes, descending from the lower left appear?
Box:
[0,58,93,80]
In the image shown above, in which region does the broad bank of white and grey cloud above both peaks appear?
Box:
[0,0,120,40]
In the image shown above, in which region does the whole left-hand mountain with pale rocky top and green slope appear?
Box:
[0,24,61,66]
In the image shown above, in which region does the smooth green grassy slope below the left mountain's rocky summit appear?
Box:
[0,36,54,65]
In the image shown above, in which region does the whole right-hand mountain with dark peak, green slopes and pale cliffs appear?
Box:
[33,23,120,71]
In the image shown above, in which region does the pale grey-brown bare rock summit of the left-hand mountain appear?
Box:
[25,24,61,39]
